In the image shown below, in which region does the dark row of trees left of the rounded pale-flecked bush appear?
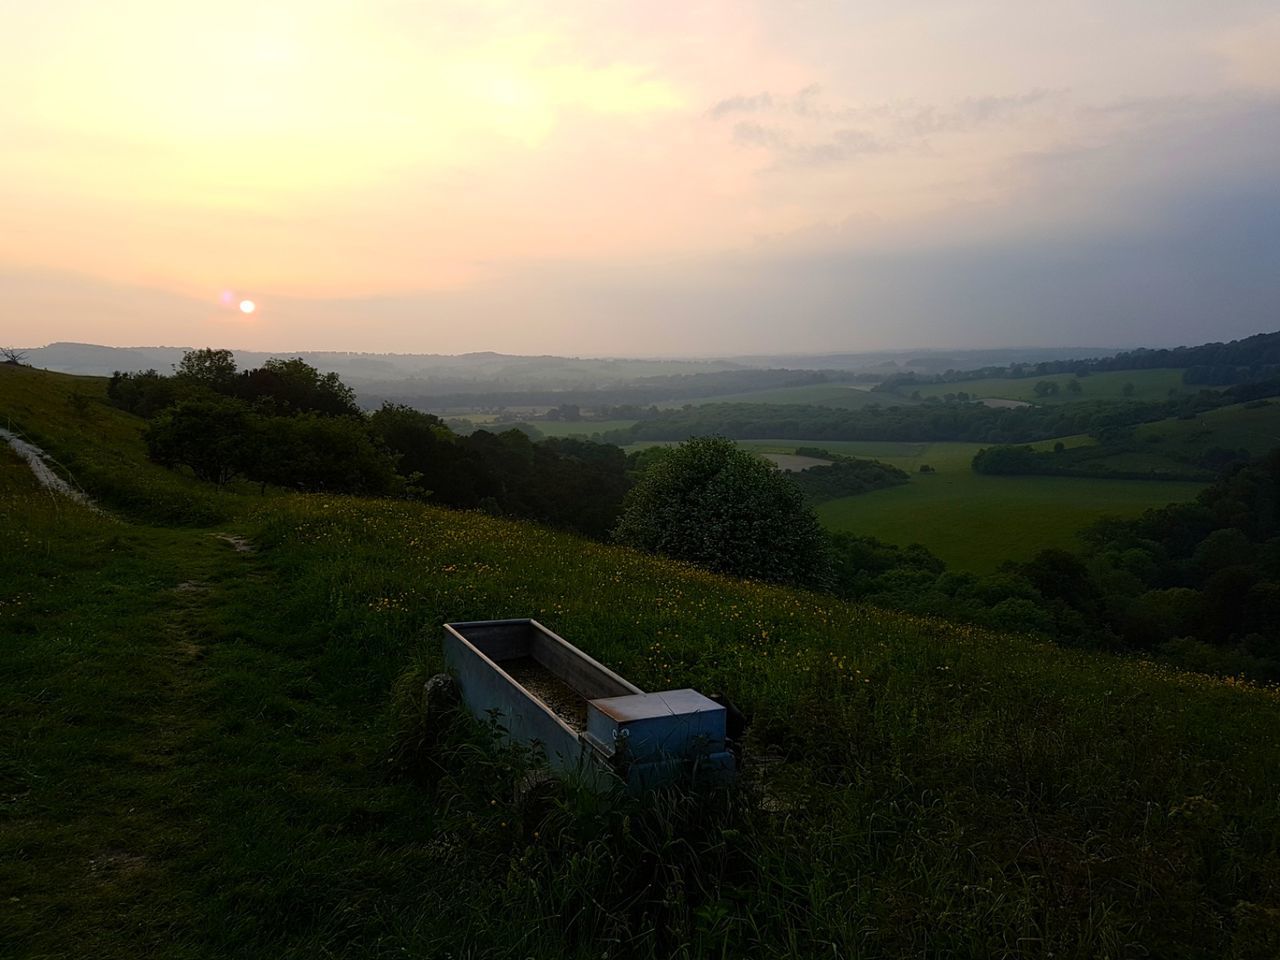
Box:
[108,349,631,536]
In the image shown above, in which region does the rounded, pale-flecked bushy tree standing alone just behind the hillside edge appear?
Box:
[613,436,829,585]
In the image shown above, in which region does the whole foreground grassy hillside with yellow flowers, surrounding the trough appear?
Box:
[0,370,1280,957]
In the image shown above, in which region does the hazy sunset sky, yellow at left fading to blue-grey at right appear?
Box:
[0,0,1280,356]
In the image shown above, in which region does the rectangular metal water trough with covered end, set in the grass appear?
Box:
[444,620,733,790]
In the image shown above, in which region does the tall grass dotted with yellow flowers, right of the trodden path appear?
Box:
[252,498,1280,956]
